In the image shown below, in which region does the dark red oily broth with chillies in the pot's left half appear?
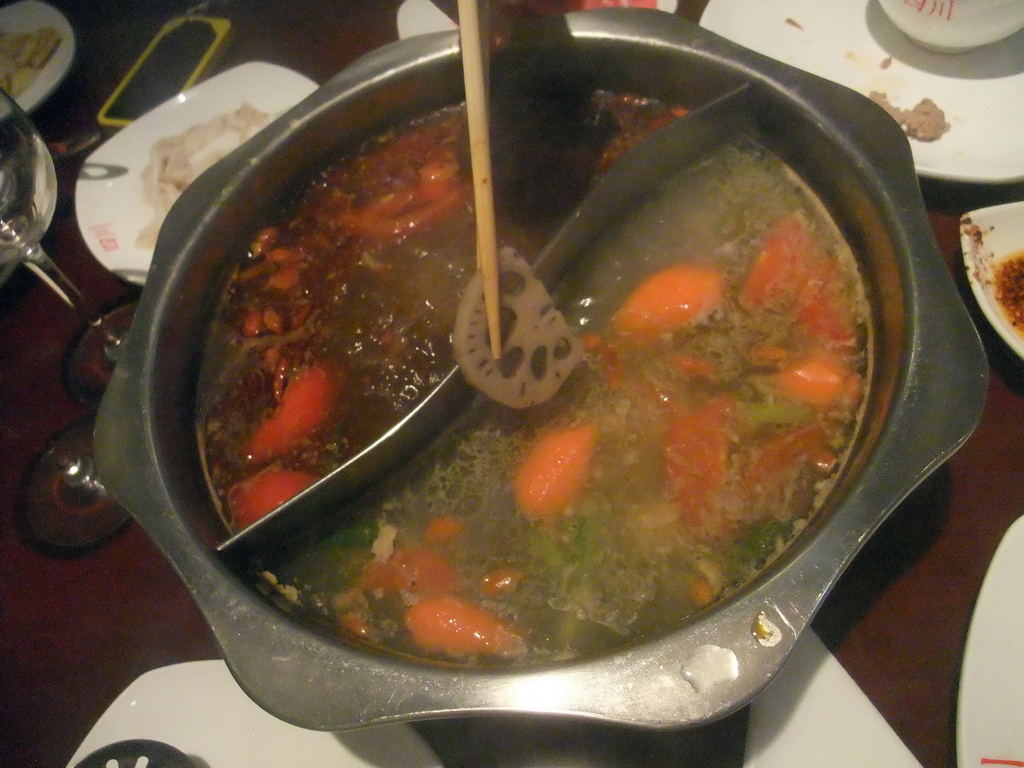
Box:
[200,92,683,529]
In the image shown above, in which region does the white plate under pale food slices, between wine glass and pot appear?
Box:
[75,61,316,284]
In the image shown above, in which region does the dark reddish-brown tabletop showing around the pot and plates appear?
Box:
[0,0,1024,768]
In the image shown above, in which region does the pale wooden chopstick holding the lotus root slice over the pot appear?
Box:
[459,0,502,359]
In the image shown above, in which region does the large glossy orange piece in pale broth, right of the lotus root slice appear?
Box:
[611,264,724,338]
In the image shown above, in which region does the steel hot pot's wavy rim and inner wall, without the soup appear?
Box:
[96,10,987,730]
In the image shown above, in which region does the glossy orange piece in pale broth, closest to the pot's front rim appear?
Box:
[406,596,525,656]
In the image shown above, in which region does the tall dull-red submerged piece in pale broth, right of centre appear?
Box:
[665,395,735,529]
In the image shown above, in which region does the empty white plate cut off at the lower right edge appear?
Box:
[956,519,1024,768]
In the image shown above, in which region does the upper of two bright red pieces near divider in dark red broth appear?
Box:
[244,368,335,463]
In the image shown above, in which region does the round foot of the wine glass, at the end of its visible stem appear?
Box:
[65,299,137,409]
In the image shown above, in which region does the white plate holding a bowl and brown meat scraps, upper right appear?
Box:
[700,0,1024,182]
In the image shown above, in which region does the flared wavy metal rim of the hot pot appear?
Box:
[96,10,987,730]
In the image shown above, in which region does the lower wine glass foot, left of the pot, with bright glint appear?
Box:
[18,417,130,553]
